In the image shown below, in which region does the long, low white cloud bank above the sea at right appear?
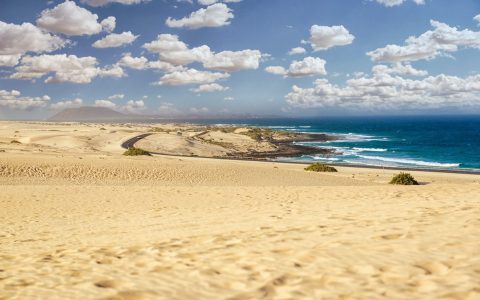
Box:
[286,73,480,110]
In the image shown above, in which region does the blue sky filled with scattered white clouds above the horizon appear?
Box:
[0,0,480,119]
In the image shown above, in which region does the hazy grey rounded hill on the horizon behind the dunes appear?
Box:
[48,106,136,122]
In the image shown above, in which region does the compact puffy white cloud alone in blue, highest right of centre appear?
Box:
[310,25,355,51]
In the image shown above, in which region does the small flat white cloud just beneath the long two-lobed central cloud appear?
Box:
[159,69,230,85]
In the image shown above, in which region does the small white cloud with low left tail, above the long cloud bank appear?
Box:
[265,57,327,77]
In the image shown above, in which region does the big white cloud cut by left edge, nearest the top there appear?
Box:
[0,21,69,58]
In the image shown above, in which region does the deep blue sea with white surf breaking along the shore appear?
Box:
[190,116,480,172]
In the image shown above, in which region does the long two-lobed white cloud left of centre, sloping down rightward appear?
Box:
[143,34,262,72]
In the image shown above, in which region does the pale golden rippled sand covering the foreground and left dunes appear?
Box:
[0,122,480,299]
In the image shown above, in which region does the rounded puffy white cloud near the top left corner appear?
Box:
[37,0,114,35]
